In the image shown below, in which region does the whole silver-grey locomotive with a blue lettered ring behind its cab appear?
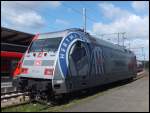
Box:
[13,28,136,99]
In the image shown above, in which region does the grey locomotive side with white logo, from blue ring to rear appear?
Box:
[85,39,136,86]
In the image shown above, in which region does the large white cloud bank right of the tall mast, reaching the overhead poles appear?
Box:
[93,15,149,55]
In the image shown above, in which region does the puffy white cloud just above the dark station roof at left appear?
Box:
[2,10,45,28]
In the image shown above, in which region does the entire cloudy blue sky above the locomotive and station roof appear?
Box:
[1,1,149,59]
